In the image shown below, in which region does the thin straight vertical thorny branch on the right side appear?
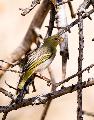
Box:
[77,11,84,120]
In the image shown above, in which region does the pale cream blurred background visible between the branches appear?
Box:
[0,0,94,120]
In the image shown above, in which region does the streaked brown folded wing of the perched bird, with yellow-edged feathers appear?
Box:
[24,47,52,71]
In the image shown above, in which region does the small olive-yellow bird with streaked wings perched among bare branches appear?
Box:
[17,30,63,100]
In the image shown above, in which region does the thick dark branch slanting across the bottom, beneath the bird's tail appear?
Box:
[0,80,94,113]
